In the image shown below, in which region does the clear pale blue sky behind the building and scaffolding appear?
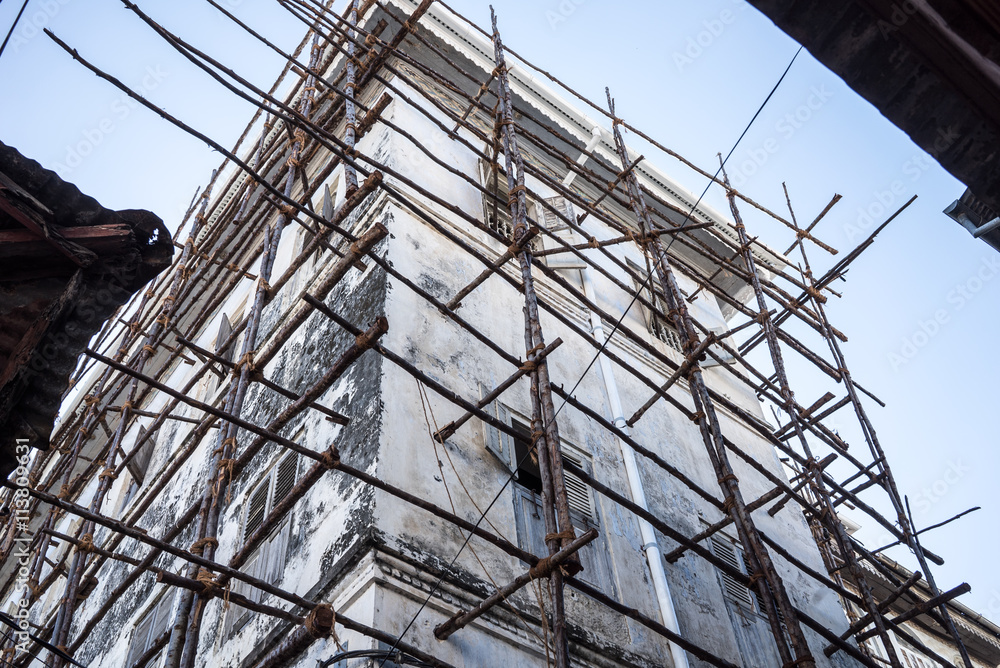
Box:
[0,0,1000,622]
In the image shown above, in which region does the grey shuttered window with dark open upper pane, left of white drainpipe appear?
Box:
[483,388,615,596]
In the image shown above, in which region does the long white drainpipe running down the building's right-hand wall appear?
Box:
[580,268,688,668]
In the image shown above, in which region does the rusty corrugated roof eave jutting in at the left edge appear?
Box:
[0,143,173,477]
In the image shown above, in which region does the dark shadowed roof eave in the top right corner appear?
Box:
[749,0,1000,211]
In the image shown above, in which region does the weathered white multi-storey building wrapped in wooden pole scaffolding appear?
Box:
[0,0,984,668]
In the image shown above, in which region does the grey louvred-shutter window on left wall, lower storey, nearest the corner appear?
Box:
[225,452,298,636]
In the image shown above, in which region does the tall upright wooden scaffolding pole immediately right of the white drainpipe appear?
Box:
[605,90,816,668]
